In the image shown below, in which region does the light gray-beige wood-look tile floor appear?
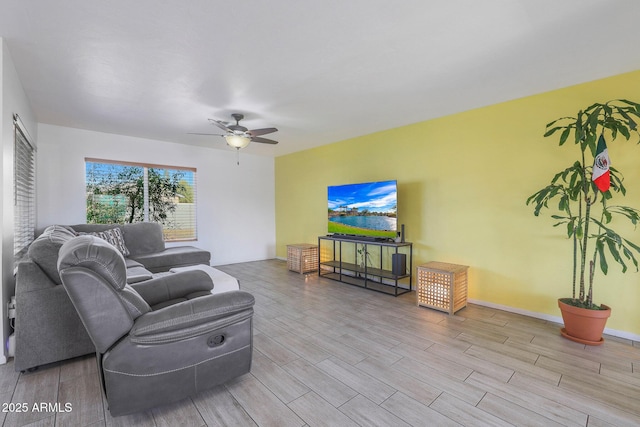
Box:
[0,260,640,427]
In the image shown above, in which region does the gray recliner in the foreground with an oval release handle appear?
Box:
[58,236,254,416]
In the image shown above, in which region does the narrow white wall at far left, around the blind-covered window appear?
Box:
[0,38,37,363]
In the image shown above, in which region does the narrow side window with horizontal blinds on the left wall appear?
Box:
[13,114,36,262]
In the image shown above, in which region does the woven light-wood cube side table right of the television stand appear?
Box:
[416,261,469,314]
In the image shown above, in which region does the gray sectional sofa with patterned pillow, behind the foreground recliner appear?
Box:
[14,222,211,371]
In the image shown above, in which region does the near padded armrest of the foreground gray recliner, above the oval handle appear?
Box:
[129,291,255,344]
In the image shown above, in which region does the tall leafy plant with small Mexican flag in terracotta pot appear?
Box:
[527,100,640,345]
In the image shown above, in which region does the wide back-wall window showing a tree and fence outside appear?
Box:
[85,159,197,241]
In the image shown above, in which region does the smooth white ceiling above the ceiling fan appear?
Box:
[0,0,640,156]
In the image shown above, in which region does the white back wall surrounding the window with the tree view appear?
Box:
[37,124,275,265]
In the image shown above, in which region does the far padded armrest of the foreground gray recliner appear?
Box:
[131,270,213,306]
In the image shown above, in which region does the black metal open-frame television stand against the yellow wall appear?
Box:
[318,235,413,297]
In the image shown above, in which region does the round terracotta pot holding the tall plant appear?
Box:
[558,300,611,345]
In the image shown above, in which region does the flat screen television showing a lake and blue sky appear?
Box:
[327,180,398,239]
